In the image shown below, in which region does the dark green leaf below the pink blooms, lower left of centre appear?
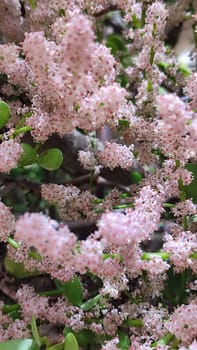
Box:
[55,276,83,306]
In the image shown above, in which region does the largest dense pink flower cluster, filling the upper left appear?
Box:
[20,15,126,140]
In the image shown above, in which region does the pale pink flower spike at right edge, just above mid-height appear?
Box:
[156,94,197,162]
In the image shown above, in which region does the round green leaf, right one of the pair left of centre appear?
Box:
[38,148,64,170]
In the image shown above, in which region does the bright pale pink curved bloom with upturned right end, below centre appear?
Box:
[99,186,163,246]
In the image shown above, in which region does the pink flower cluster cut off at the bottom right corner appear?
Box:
[165,301,197,345]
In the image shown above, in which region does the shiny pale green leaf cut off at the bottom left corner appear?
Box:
[0,339,40,350]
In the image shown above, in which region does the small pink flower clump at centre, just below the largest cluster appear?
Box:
[97,142,134,170]
